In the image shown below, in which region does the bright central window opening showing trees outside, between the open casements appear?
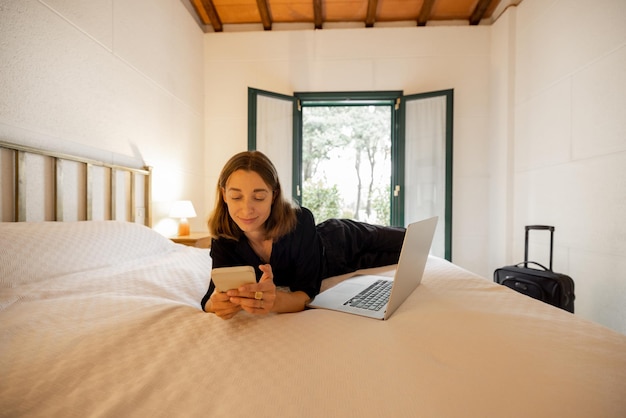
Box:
[302,105,391,225]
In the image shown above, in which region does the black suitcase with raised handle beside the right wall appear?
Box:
[493,225,575,313]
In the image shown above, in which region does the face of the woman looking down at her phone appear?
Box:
[222,170,274,235]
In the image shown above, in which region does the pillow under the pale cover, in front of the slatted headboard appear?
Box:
[0,221,176,287]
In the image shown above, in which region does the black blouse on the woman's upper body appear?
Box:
[202,208,324,309]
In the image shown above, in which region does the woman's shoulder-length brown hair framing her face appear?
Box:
[208,151,300,241]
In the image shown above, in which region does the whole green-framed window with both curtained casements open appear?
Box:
[248,88,453,260]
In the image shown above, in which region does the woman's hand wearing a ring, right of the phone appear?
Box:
[227,264,276,315]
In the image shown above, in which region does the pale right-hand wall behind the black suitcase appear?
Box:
[490,0,626,334]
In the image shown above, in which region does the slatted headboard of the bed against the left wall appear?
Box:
[0,141,152,226]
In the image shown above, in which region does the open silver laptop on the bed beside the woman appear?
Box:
[309,216,438,319]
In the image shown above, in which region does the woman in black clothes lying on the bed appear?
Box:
[202,151,405,319]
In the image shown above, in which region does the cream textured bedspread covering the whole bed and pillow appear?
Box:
[0,222,626,417]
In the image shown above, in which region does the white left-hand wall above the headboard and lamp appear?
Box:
[0,0,207,233]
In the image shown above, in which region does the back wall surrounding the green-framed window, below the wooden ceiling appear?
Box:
[205,27,490,276]
